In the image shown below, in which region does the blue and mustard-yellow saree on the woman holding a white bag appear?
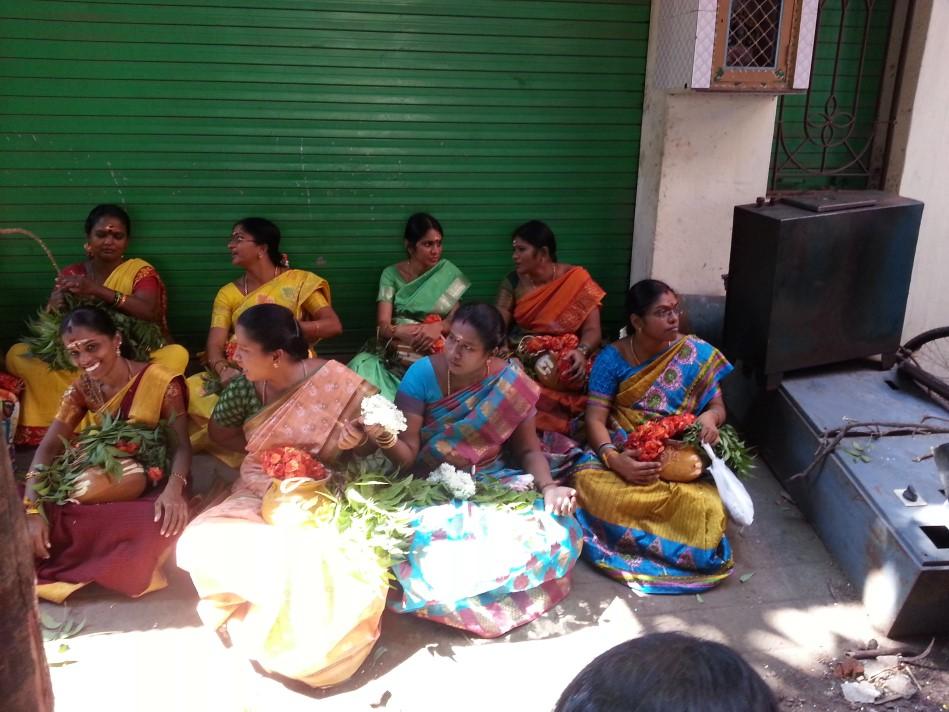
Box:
[574,337,732,594]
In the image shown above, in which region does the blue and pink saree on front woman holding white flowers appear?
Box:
[389,359,581,638]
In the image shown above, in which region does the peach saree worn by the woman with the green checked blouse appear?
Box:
[177,361,387,687]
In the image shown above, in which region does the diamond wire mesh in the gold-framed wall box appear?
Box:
[725,0,784,69]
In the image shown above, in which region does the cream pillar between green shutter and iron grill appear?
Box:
[631,2,777,295]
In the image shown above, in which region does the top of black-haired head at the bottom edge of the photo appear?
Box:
[554,633,778,712]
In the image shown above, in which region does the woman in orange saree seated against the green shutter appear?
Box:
[496,220,606,433]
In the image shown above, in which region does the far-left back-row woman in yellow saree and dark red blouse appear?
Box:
[7,205,188,445]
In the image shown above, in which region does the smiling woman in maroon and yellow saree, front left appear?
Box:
[24,307,191,603]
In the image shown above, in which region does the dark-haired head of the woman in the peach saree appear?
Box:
[235,304,309,381]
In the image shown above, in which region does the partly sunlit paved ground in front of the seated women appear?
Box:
[42,464,949,712]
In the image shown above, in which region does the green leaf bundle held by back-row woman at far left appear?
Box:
[25,294,166,371]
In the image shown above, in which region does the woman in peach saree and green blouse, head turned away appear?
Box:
[177,304,387,687]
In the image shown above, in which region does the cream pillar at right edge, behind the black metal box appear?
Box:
[885,0,949,341]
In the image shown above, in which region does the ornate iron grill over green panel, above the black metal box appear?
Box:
[769,0,905,192]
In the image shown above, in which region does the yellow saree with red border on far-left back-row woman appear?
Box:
[7,258,189,445]
